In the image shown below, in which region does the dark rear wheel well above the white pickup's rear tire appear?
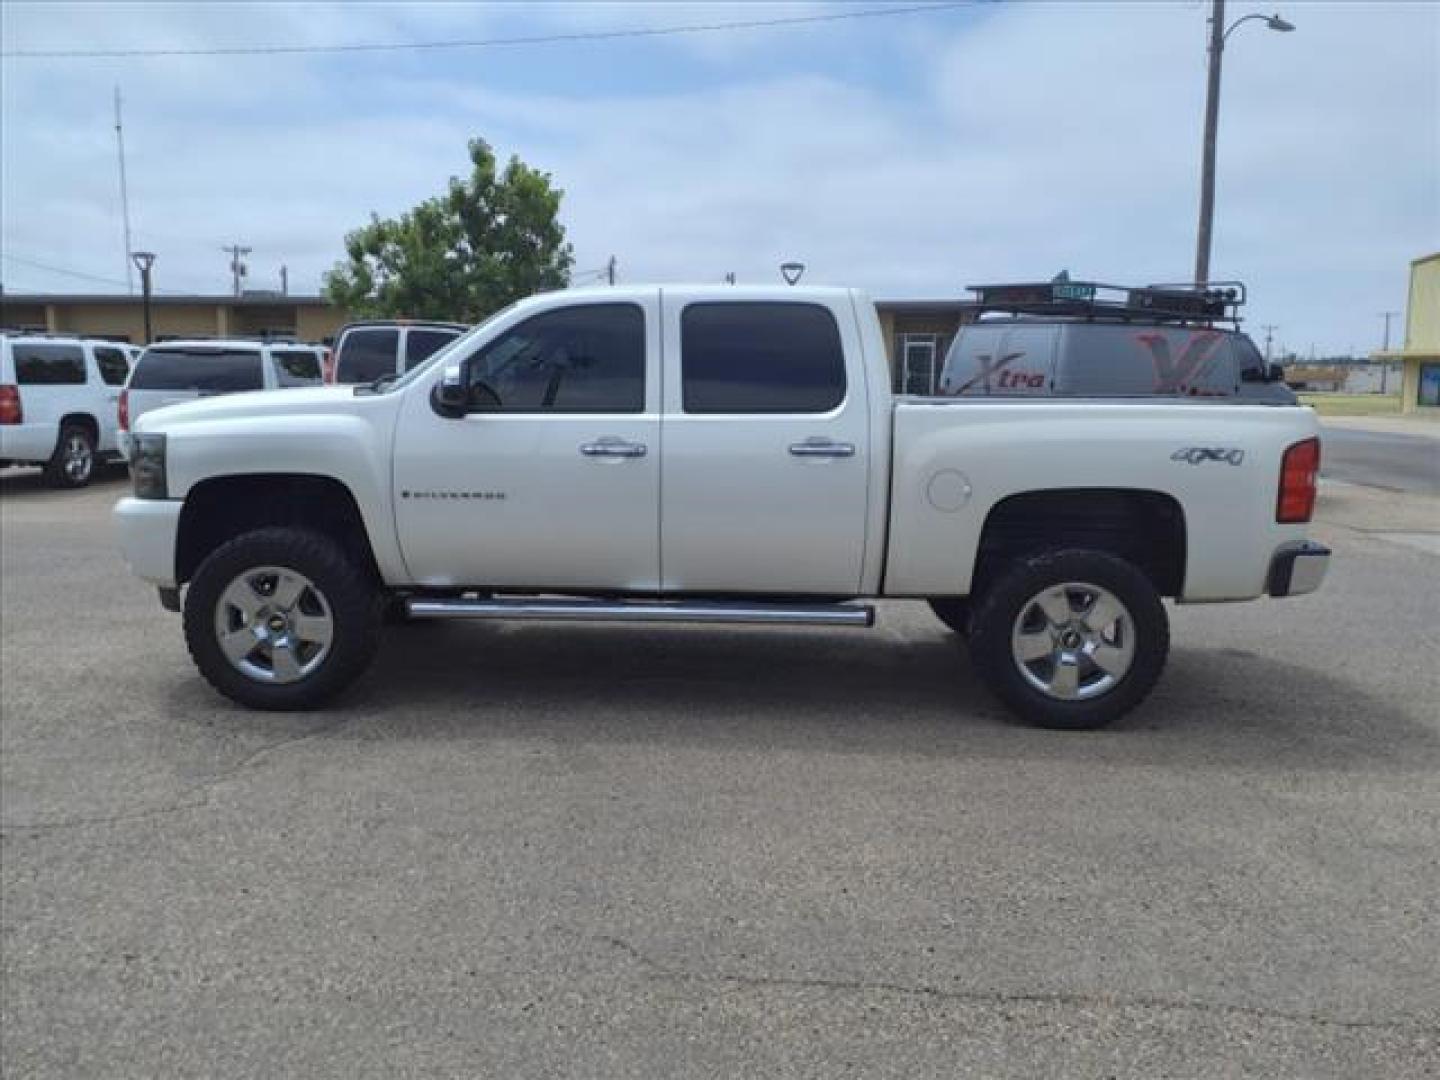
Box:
[971,488,1185,596]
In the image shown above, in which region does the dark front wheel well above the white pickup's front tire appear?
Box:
[176,472,380,582]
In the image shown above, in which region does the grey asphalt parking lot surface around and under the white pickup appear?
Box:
[0,472,1440,1079]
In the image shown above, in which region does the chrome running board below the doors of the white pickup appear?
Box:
[405,596,876,626]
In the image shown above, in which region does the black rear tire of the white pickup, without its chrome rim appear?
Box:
[969,549,1169,730]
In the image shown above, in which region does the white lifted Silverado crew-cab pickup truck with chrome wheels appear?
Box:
[115,285,1329,727]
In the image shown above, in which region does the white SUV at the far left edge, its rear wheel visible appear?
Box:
[0,334,130,488]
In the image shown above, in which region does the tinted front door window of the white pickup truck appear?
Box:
[469,304,645,412]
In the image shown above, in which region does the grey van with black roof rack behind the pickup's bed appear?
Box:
[939,282,1296,405]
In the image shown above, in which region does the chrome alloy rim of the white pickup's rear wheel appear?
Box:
[1009,582,1135,701]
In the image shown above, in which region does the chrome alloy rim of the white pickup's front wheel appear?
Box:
[215,566,336,683]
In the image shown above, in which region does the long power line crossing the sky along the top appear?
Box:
[0,0,979,60]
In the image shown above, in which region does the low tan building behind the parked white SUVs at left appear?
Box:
[0,292,347,344]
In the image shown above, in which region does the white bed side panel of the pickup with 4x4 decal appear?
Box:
[884,399,1319,600]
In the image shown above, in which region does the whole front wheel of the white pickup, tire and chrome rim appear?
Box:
[184,528,382,708]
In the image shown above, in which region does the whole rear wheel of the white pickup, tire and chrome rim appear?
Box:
[971,550,1169,730]
